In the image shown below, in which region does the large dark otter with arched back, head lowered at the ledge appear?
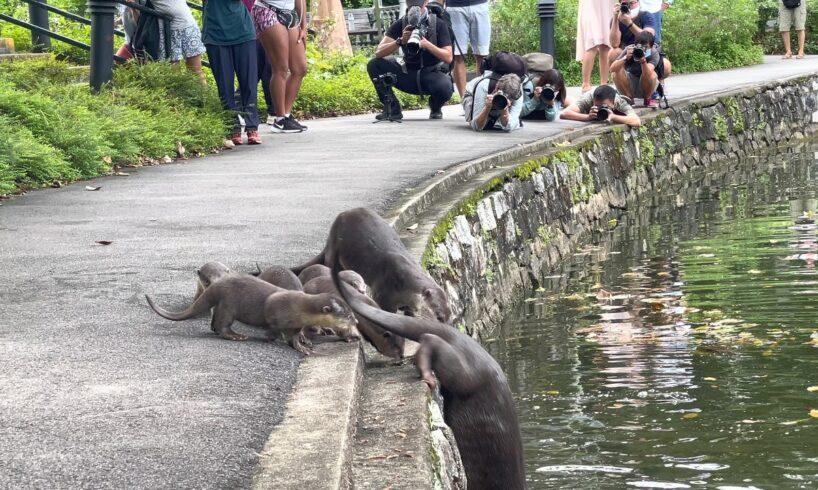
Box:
[293,208,451,323]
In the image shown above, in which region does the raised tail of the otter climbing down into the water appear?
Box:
[332,262,440,342]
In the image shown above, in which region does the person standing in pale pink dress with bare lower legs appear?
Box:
[576,0,613,93]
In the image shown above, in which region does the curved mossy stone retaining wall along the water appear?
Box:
[423,76,818,338]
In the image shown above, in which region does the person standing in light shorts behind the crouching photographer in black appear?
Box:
[446,0,491,97]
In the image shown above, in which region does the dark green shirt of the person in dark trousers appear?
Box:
[202,0,256,46]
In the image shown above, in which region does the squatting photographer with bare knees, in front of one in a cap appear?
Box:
[611,31,670,107]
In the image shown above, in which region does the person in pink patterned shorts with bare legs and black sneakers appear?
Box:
[253,0,307,133]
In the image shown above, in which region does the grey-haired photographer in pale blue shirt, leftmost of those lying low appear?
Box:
[463,71,523,132]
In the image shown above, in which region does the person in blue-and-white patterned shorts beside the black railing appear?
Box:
[151,0,205,78]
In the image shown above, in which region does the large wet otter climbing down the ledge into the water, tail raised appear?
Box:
[333,263,525,490]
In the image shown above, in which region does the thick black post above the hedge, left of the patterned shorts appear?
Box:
[88,0,116,92]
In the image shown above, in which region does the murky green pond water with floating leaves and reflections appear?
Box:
[488,144,818,490]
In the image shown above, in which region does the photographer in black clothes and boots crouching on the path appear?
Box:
[366,0,454,121]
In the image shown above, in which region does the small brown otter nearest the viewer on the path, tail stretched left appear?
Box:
[145,273,357,355]
